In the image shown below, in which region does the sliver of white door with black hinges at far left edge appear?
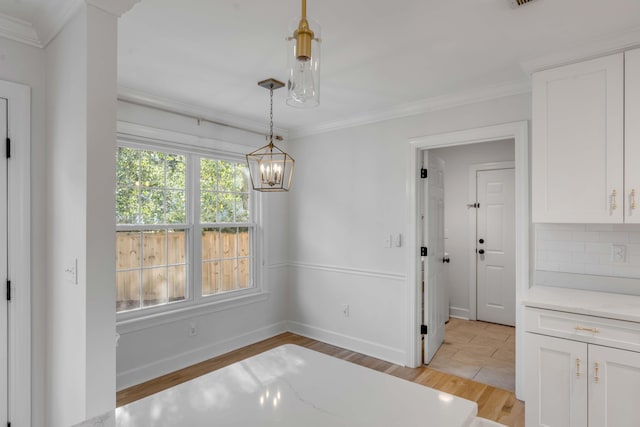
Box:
[0,98,9,424]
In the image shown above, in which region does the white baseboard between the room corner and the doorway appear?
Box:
[286,321,406,366]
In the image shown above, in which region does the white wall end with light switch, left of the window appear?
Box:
[45,4,117,426]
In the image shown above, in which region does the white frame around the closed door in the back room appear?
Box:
[467,162,516,320]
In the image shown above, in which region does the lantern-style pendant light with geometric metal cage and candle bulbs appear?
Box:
[246,79,295,192]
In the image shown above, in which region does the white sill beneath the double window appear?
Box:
[116,291,269,335]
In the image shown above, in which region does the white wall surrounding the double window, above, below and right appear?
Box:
[117,102,289,389]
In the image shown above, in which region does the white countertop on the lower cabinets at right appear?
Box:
[522,286,640,322]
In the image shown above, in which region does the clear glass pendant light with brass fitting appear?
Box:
[287,0,320,108]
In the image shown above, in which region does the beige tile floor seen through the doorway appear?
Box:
[429,317,516,392]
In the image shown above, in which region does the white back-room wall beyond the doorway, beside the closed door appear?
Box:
[429,140,515,318]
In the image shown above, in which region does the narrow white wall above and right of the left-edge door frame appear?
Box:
[0,37,46,427]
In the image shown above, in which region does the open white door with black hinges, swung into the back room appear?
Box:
[422,151,449,363]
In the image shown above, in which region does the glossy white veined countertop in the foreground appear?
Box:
[116,344,477,427]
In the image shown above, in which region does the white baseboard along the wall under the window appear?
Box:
[116,322,288,391]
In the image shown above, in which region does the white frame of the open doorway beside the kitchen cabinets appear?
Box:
[406,120,530,399]
